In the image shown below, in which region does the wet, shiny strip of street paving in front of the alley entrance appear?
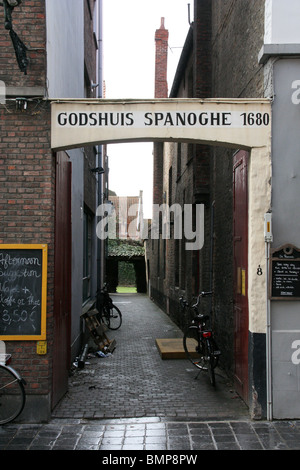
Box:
[0,418,300,450]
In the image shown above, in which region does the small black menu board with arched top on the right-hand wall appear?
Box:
[271,245,300,300]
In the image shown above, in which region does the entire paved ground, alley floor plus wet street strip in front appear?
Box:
[0,295,300,452]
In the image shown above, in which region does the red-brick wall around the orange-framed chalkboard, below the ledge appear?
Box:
[0,102,55,400]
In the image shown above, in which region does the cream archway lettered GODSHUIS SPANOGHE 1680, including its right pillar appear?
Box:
[51,99,271,408]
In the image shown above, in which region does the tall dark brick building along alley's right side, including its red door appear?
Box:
[147,0,290,418]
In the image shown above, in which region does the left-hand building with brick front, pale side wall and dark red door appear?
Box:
[0,0,101,422]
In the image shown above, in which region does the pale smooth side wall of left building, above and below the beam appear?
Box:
[46,0,85,357]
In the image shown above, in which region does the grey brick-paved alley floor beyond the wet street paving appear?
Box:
[53,294,249,420]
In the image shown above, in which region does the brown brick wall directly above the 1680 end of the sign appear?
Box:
[212,0,265,98]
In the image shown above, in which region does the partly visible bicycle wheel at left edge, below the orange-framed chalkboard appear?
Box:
[0,364,26,424]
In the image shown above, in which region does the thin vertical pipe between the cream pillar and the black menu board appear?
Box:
[264,212,273,421]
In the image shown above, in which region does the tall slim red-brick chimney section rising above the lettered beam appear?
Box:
[154,18,169,98]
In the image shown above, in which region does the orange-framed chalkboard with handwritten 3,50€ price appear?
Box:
[0,245,47,341]
